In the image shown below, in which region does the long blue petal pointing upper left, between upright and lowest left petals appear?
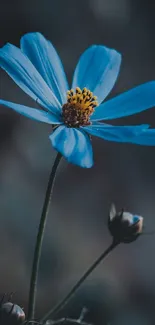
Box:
[0,44,61,113]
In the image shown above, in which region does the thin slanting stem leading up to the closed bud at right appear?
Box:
[41,240,119,322]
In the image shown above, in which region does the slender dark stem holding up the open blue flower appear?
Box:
[28,153,62,320]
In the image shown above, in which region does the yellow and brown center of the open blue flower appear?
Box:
[62,87,98,128]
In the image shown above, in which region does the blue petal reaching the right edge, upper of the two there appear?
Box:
[91,81,155,121]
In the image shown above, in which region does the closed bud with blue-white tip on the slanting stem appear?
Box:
[108,204,143,243]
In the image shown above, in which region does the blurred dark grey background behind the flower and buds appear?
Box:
[0,0,155,325]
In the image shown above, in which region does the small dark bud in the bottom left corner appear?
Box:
[0,302,25,325]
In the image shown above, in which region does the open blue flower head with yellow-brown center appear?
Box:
[0,33,155,168]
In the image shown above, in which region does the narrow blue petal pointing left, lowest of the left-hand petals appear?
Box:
[0,100,62,124]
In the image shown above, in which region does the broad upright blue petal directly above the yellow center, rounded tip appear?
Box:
[72,45,121,104]
